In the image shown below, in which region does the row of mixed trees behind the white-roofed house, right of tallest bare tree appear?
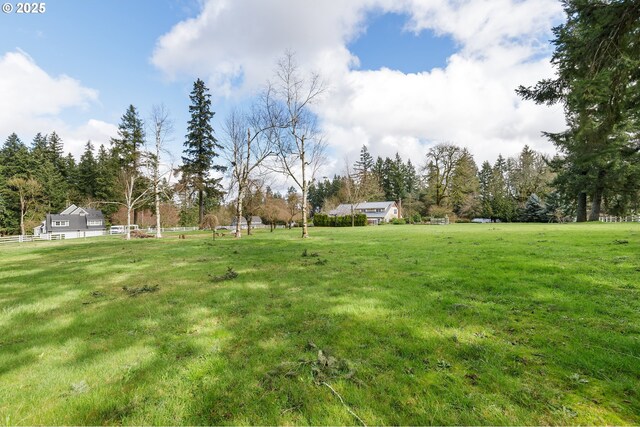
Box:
[310,144,571,221]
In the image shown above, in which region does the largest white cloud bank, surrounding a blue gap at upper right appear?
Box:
[152,0,564,174]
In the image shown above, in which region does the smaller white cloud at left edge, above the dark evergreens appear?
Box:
[0,50,117,156]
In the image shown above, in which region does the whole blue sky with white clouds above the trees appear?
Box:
[0,0,564,174]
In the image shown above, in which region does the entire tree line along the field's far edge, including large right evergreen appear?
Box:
[0,0,640,237]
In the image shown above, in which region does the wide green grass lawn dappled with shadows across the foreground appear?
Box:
[0,224,640,425]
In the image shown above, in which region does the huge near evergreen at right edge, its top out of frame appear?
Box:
[518,0,640,222]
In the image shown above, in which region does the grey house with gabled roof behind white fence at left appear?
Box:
[33,205,106,239]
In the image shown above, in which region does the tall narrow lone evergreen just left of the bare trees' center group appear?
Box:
[181,79,225,226]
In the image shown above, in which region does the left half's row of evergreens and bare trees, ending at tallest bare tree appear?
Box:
[0,52,325,238]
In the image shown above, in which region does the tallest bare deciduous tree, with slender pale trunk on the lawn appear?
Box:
[267,52,326,238]
